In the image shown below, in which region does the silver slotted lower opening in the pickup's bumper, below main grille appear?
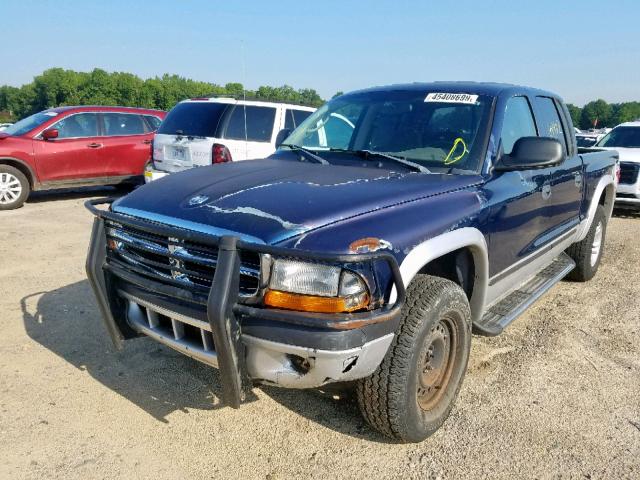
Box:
[118,290,218,368]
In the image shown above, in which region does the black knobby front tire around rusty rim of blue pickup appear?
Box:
[356,275,471,442]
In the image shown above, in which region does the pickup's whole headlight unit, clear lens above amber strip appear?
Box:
[264,260,369,313]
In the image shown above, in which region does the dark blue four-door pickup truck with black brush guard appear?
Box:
[87,82,618,442]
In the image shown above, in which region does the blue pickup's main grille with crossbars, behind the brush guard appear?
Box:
[105,221,260,298]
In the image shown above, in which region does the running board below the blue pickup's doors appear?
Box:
[473,252,576,337]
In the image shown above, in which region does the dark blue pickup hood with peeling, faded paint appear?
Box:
[112,159,482,244]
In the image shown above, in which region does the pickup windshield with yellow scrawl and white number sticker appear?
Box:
[285,90,492,172]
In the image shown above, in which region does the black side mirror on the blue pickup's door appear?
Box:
[495,137,564,172]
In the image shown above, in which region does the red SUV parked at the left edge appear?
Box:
[0,107,166,210]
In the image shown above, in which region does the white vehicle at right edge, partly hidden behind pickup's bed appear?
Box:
[595,121,640,209]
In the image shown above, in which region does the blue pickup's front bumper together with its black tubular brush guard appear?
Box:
[86,201,405,407]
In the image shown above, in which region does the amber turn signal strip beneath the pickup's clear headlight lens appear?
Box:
[264,290,369,313]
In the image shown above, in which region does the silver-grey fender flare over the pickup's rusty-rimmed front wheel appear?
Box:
[390,227,489,322]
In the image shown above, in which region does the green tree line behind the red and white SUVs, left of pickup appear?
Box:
[0,68,324,121]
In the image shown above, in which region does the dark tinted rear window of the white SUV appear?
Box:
[157,102,229,137]
